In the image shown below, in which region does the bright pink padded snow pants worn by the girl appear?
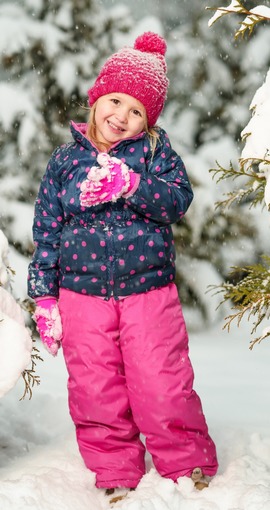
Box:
[59,284,217,488]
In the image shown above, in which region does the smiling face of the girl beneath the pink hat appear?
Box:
[95,92,147,146]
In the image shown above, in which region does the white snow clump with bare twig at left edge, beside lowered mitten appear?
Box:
[0,230,35,398]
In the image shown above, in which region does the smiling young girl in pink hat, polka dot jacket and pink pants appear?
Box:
[29,32,217,498]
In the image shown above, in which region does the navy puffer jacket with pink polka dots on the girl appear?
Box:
[28,123,193,299]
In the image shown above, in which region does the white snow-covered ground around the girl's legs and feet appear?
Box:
[0,316,270,510]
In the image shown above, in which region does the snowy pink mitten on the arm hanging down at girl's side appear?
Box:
[33,297,62,356]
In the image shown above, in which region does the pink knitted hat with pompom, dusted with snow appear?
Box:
[88,32,169,127]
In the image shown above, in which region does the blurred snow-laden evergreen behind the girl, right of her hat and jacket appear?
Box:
[160,0,270,320]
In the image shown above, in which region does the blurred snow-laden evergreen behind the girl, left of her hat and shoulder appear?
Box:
[0,0,130,255]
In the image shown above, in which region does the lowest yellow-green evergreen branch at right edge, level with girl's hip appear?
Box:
[210,255,270,349]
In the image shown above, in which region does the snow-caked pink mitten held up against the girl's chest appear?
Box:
[80,152,134,207]
